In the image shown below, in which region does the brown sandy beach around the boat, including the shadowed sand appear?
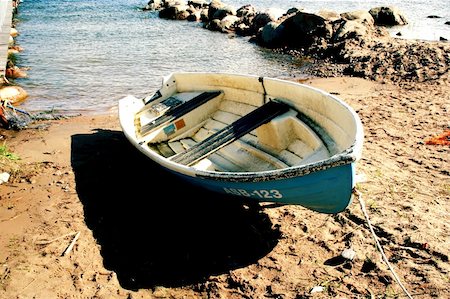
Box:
[0,77,450,299]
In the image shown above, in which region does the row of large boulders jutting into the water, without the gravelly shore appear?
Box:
[144,0,407,52]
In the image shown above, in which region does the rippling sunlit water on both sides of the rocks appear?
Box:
[15,0,450,113]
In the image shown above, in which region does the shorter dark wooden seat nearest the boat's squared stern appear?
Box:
[141,91,221,135]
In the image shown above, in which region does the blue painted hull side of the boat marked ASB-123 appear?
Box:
[169,163,355,214]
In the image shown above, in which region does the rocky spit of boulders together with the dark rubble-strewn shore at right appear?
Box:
[143,0,450,81]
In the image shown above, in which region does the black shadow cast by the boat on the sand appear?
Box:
[71,130,280,290]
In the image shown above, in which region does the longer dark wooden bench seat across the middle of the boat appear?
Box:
[170,101,289,166]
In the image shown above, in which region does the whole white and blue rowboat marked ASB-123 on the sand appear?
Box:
[118,72,364,214]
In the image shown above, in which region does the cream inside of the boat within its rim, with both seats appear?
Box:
[135,81,352,172]
